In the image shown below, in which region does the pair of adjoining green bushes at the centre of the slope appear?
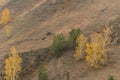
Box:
[50,28,81,57]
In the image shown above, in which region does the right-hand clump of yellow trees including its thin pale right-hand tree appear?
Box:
[86,27,111,68]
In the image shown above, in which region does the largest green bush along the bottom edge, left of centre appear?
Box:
[39,63,49,80]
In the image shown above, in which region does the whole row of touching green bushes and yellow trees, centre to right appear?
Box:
[50,27,111,69]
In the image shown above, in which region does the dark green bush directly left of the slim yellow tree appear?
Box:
[67,28,81,48]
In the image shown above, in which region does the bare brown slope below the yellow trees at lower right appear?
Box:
[46,46,120,80]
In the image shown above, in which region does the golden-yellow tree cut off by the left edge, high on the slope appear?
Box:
[0,8,10,24]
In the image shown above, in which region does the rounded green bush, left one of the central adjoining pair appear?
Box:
[50,34,67,57]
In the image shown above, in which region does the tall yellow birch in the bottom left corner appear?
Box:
[5,46,22,80]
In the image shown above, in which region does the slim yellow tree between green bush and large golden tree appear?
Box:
[74,34,87,60]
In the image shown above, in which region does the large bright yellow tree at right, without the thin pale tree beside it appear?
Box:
[86,33,107,69]
